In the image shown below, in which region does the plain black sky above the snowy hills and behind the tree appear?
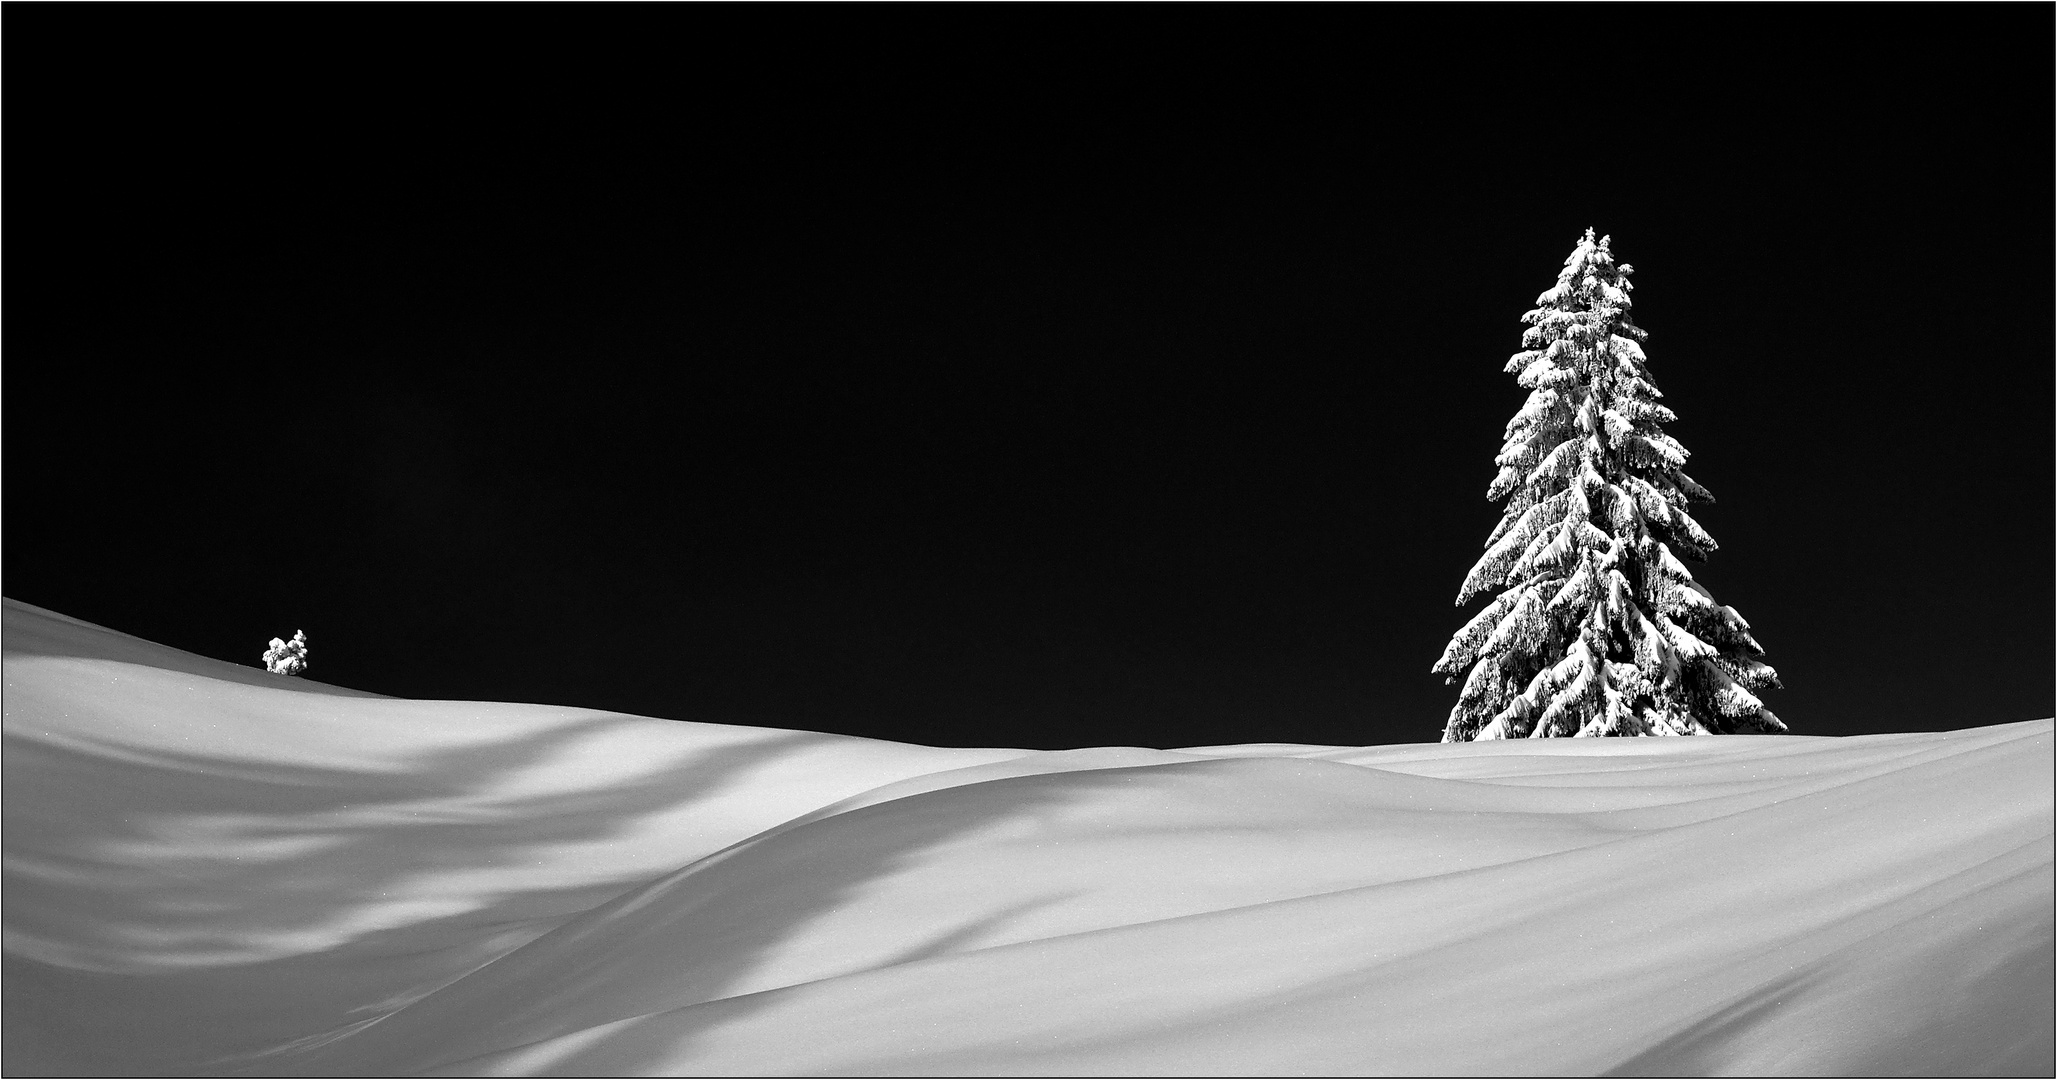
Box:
[4,4,2057,747]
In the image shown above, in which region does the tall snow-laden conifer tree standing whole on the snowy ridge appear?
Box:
[1432,228,1785,743]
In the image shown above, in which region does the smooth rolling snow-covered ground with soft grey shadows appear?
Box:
[0,601,2057,1076]
